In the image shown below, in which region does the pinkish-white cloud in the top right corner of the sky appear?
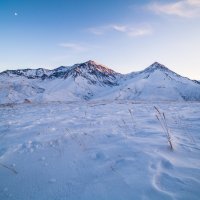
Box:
[147,0,200,18]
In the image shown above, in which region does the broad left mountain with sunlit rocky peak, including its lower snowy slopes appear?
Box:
[0,61,120,104]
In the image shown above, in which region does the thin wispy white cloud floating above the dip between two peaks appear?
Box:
[88,24,153,37]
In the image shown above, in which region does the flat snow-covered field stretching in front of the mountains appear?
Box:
[0,101,200,200]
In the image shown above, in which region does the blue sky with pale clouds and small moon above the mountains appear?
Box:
[0,0,200,80]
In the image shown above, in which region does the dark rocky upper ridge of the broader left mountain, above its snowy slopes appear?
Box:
[0,60,118,86]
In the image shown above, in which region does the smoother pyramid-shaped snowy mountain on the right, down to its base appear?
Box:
[111,62,200,100]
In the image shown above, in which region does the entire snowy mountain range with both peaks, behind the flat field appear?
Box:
[0,60,200,104]
